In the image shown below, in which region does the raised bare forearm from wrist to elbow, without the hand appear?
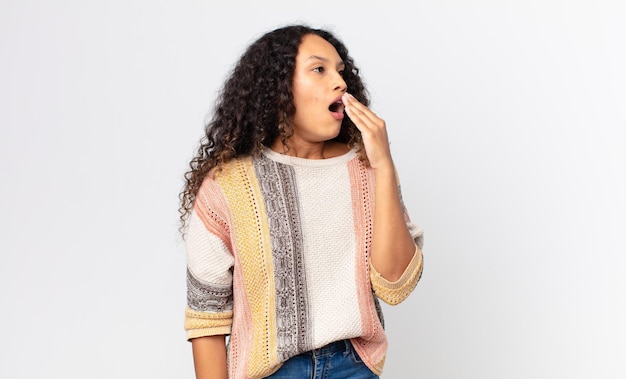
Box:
[371,162,415,282]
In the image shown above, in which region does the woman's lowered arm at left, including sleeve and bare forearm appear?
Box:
[184,181,234,379]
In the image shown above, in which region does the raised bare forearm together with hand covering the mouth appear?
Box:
[342,94,419,282]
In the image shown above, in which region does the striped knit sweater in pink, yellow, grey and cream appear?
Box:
[185,149,422,379]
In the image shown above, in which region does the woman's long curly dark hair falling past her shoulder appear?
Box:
[178,25,369,234]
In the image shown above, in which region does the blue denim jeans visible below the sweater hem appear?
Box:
[266,340,378,379]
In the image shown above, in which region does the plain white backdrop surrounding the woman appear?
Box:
[0,0,626,379]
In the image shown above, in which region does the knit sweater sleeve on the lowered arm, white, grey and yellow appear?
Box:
[184,180,234,339]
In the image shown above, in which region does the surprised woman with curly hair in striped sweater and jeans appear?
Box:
[180,25,422,378]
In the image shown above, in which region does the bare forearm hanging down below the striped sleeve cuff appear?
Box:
[191,335,228,379]
